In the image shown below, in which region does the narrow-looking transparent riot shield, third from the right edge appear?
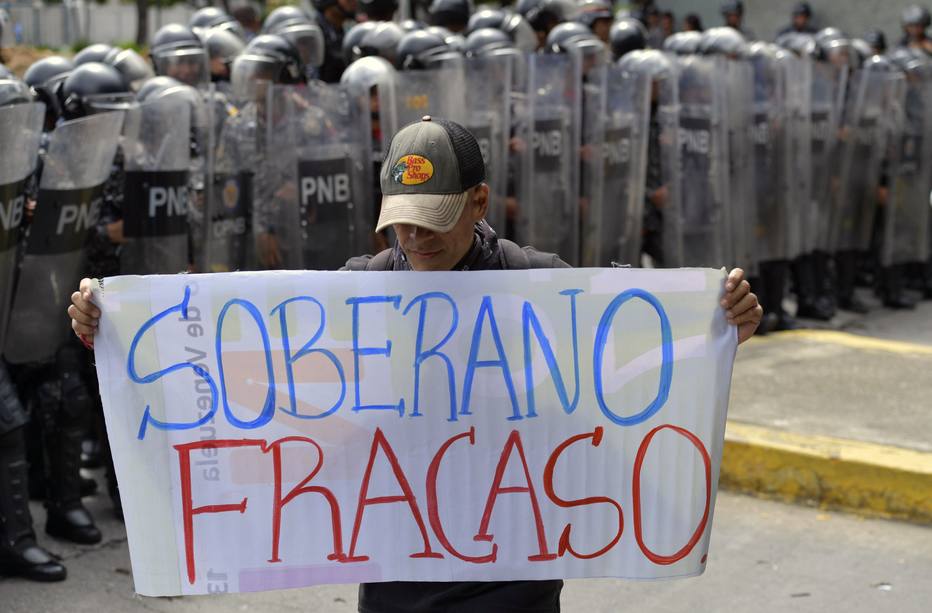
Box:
[802,61,848,253]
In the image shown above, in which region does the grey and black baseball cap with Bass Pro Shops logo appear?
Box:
[375,115,485,232]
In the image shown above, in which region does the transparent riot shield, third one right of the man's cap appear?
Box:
[580,66,651,266]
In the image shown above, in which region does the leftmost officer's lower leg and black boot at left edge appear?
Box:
[0,428,68,581]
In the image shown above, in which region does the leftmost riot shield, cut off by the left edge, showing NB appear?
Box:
[0,102,45,347]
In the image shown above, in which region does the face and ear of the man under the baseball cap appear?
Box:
[392,183,489,272]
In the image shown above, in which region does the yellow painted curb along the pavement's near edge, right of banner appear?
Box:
[720,421,932,524]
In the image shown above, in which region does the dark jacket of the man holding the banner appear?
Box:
[344,220,569,613]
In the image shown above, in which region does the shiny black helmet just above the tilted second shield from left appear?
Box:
[58,62,133,120]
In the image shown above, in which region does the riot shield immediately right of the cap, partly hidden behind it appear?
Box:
[463,56,513,238]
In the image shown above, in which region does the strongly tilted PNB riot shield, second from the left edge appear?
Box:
[3,112,123,364]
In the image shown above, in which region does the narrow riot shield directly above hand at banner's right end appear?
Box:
[716,57,757,275]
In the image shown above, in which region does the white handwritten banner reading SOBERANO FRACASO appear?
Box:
[95,269,737,596]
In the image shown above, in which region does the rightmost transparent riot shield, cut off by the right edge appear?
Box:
[881,63,932,266]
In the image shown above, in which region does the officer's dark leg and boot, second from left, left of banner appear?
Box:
[36,345,102,544]
